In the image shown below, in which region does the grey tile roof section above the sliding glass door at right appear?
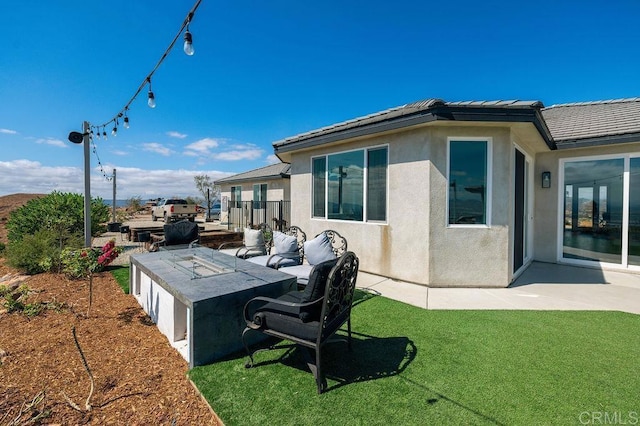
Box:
[542,98,640,146]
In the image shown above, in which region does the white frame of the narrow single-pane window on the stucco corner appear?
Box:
[444,136,493,228]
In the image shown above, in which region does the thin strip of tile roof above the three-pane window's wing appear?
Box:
[273,98,544,147]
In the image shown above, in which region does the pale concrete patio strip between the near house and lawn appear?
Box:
[357,262,640,314]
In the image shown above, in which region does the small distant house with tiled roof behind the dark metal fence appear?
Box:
[214,163,291,228]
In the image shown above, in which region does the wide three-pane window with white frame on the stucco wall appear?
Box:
[312,146,388,221]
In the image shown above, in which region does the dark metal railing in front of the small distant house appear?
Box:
[227,200,291,231]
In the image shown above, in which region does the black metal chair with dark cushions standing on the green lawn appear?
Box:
[242,252,359,393]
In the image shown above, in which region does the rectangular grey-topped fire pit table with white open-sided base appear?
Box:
[129,247,296,367]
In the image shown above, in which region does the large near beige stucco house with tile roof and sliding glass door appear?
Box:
[273,98,640,287]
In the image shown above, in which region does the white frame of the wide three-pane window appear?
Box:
[309,143,389,225]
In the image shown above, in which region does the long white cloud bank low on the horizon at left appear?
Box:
[0,160,234,200]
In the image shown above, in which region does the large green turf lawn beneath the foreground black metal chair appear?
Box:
[189,293,640,425]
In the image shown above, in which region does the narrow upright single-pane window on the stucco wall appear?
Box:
[448,139,491,225]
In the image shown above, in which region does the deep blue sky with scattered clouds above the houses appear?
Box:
[0,0,640,199]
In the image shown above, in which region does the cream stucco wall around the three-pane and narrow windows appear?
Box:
[291,124,541,287]
